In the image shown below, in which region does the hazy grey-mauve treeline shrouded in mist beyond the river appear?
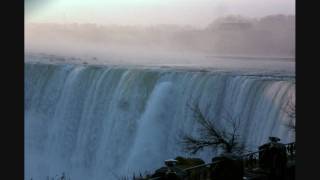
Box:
[25,15,295,57]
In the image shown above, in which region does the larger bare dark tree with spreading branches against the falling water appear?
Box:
[182,105,244,154]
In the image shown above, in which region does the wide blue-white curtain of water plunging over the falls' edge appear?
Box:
[25,63,295,180]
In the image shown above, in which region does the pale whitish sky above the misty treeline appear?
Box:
[25,0,295,27]
